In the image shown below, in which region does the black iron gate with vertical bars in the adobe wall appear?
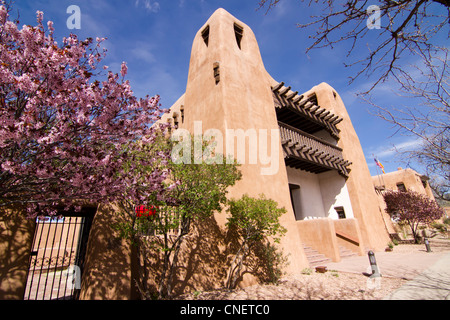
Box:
[24,208,95,300]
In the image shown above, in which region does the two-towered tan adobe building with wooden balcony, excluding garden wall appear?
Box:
[162,9,389,273]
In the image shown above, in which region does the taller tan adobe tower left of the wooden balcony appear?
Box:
[178,9,308,278]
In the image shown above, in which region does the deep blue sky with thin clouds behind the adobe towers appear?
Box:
[8,0,442,175]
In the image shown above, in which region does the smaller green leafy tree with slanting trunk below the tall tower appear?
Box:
[226,194,286,289]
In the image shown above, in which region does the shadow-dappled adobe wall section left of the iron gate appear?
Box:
[0,209,36,300]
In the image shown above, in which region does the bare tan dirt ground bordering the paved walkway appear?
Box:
[178,241,450,300]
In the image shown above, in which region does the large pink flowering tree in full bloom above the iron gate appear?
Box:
[0,6,168,216]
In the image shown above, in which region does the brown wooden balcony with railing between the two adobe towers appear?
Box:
[278,122,351,177]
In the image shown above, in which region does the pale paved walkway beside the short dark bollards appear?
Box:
[327,241,450,300]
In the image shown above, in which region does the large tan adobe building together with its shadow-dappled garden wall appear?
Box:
[0,9,389,299]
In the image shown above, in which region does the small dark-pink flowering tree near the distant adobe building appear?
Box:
[383,190,444,242]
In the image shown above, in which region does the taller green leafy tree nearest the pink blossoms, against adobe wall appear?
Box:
[121,136,241,299]
